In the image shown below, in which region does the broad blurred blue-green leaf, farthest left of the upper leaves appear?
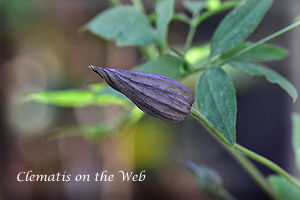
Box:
[83,6,158,46]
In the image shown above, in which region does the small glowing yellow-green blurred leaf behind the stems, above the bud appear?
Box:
[184,45,210,65]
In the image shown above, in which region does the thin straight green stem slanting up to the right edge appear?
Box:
[217,20,300,66]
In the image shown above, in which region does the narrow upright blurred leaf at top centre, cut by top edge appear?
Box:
[155,0,174,43]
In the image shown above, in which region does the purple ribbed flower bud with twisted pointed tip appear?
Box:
[89,65,194,123]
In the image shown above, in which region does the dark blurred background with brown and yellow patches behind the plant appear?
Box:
[0,0,300,200]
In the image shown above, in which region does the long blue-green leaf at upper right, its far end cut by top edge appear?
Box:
[210,0,272,57]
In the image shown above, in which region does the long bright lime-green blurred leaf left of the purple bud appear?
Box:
[25,90,128,107]
